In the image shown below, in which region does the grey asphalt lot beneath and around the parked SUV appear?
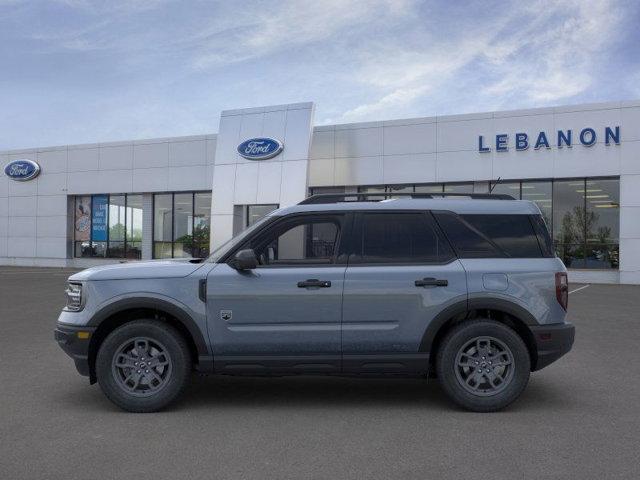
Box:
[0,267,640,480]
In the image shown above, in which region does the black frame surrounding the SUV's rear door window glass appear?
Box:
[348,209,458,267]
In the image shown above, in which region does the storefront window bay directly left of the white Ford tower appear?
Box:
[153,192,211,258]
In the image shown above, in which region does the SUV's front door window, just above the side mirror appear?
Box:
[243,216,341,266]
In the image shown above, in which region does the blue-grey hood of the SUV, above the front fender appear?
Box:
[69,258,202,281]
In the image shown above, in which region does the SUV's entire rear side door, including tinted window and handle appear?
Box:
[342,211,467,373]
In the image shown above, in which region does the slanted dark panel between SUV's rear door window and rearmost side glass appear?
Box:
[434,213,504,258]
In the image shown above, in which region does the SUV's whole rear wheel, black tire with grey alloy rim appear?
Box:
[436,319,531,412]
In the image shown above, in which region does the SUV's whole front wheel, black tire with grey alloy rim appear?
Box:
[96,320,191,413]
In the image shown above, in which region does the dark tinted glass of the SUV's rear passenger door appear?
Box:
[359,213,453,263]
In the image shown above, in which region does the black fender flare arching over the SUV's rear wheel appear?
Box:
[419,298,539,353]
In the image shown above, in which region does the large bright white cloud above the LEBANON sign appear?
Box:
[338,0,622,121]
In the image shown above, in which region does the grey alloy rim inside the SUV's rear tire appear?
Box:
[456,337,515,396]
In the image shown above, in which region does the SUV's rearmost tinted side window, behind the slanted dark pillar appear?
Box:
[462,215,542,258]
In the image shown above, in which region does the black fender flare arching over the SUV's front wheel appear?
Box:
[88,297,211,358]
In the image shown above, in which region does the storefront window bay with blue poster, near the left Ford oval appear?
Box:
[74,194,142,258]
